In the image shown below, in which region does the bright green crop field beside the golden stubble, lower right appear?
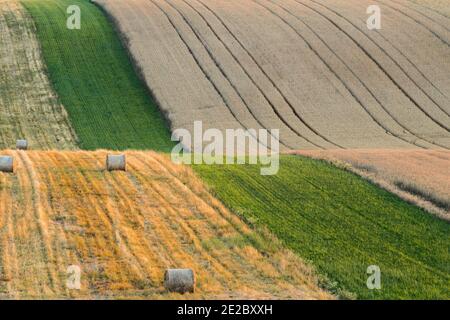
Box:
[194,156,450,299]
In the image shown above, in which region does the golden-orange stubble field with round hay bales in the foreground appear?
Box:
[0,151,332,299]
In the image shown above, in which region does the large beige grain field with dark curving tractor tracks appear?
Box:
[95,0,450,150]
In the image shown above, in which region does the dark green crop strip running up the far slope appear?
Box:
[22,0,172,151]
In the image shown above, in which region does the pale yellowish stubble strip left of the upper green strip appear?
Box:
[0,0,77,149]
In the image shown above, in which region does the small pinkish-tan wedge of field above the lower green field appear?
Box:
[298,150,450,220]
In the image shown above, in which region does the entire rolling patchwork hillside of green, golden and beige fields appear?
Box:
[0,0,450,300]
